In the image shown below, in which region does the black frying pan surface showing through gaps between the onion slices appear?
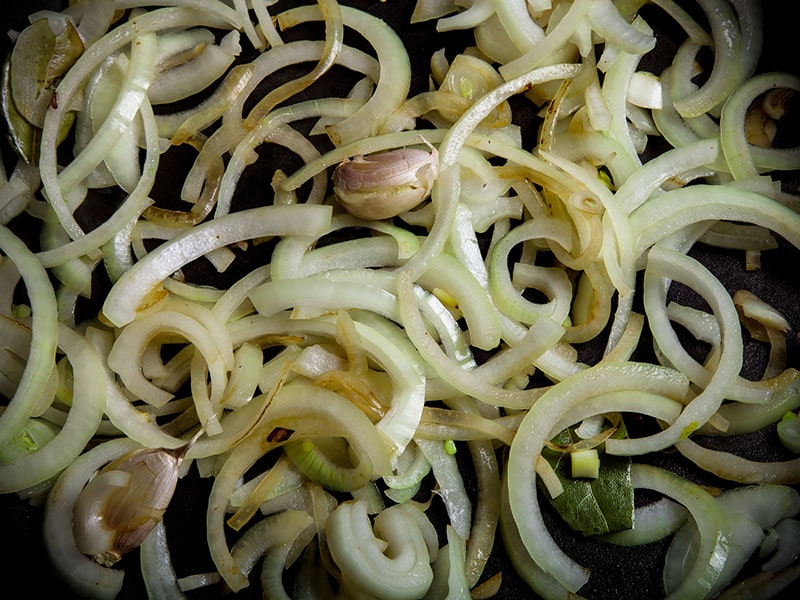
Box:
[0,0,800,600]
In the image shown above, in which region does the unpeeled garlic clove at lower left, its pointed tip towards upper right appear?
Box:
[73,447,186,566]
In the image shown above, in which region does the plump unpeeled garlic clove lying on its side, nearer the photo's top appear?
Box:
[333,144,439,220]
